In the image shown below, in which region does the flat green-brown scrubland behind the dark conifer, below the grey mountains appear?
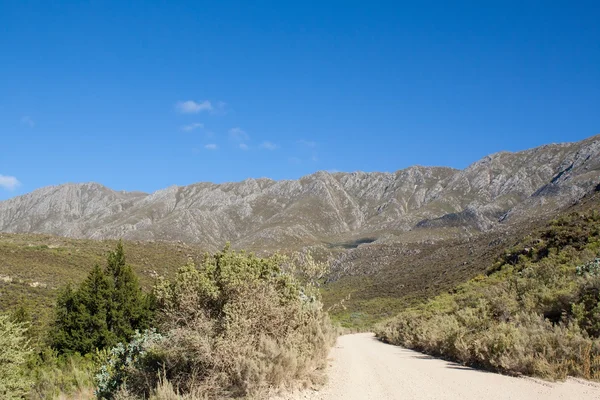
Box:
[0,233,204,324]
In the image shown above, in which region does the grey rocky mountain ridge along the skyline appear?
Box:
[0,136,600,249]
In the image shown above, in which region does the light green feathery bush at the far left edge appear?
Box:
[0,315,32,400]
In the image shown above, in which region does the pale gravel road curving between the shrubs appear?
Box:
[284,333,600,400]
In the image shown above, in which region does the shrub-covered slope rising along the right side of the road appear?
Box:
[377,211,600,380]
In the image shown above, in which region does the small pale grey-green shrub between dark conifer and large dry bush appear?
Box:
[95,329,163,399]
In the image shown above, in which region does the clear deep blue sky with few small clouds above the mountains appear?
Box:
[0,0,600,199]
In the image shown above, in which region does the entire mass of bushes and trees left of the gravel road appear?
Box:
[0,242,335,399]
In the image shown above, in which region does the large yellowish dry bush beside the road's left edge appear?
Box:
[120,248,335,399]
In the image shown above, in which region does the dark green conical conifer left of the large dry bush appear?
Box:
[50,242,153,354]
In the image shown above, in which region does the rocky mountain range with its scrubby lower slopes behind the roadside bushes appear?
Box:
[0,136,600,327]
